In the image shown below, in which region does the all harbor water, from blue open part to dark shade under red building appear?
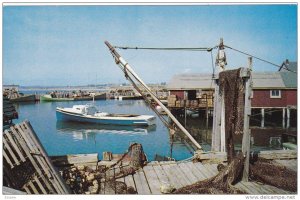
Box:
[15,95,297,160]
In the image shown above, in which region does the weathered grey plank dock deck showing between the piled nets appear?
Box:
[118,160,297,195]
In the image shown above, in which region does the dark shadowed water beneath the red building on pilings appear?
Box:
[174,112,297,151]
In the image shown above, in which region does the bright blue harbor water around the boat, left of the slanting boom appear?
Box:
[15,100,197,160]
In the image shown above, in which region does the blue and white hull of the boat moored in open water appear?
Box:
[56,108,155,126]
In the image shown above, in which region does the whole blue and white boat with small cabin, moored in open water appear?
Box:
[56,104,155,126]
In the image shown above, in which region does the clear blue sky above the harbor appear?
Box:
[3,5,297,86]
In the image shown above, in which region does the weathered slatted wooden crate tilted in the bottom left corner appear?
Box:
[2,121,71,194]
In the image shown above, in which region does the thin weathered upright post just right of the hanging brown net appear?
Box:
[242,57,252,182]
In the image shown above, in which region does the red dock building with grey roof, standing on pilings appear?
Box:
[167,62,297,128]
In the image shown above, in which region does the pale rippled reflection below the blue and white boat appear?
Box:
[56,121,156,140]
